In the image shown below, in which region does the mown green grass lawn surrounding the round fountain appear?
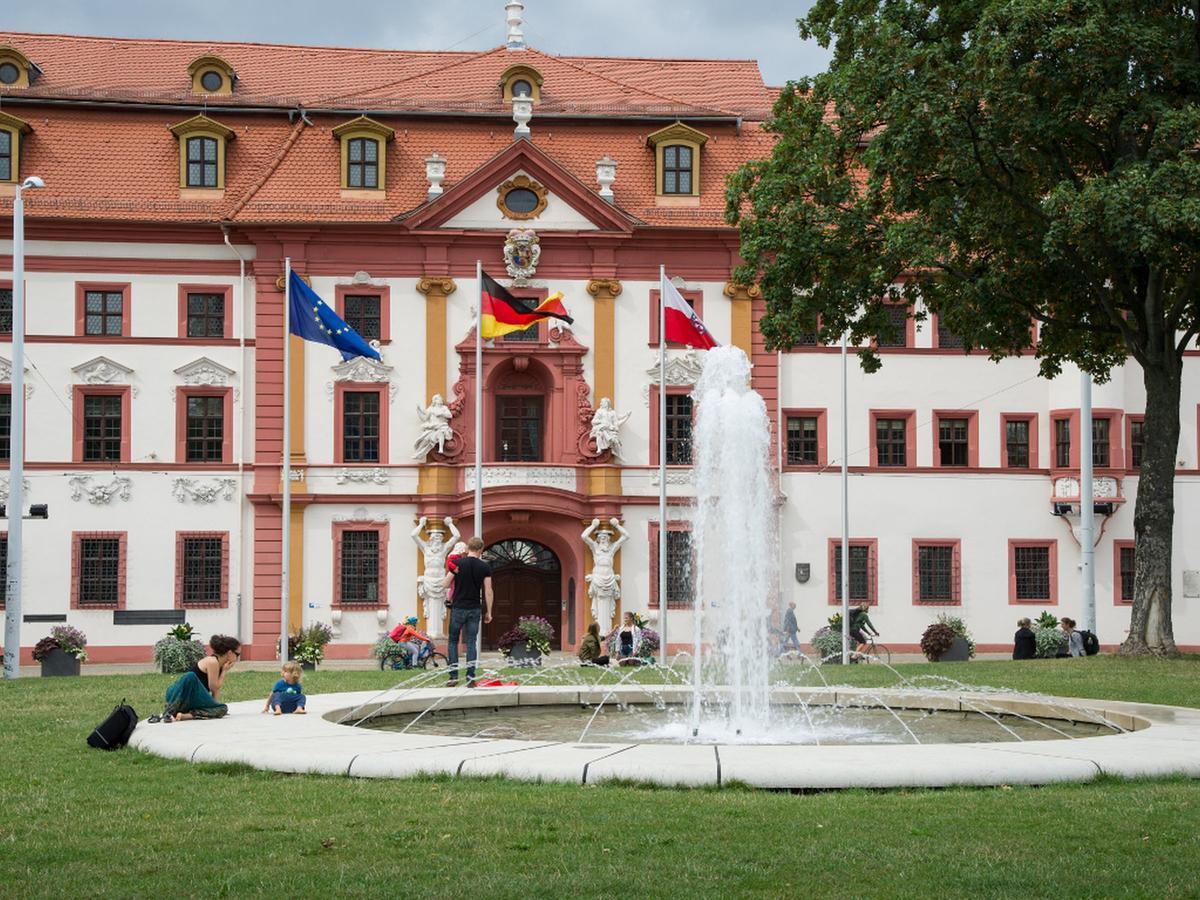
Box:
[0,656,1200,900]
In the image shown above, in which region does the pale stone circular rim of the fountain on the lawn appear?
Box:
[130,685,1200,788]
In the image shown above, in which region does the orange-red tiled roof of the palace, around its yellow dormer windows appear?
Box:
[0,34,772,227]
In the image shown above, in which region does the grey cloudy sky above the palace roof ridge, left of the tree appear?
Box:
[7,0,829,84]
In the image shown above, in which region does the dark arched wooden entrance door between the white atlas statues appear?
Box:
[484,538,563,650]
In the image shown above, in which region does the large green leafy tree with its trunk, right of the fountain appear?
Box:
[727,0,1200,654]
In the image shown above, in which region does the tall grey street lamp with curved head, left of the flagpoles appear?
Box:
[4,175,46,678]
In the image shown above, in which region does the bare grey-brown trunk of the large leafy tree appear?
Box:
[1121,354,1182,656]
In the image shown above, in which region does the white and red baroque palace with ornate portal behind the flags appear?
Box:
[0,15,1200,661]
